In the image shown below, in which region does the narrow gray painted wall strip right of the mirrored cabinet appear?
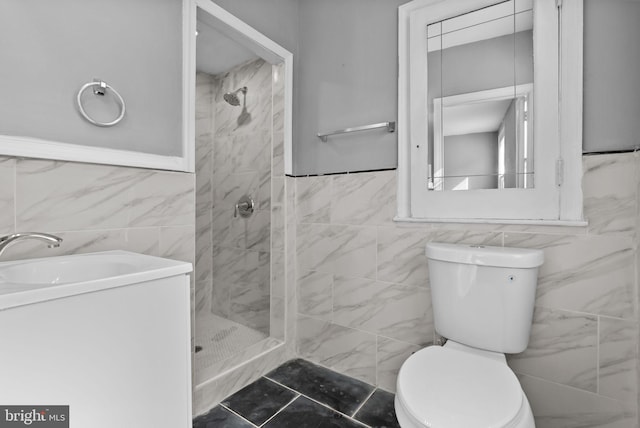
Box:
[583,0,640,152]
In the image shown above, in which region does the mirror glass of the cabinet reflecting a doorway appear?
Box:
[427,0,534,190]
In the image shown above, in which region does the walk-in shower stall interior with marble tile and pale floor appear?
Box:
[194,3,285,398]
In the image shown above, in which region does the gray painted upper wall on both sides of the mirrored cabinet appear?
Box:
[294,0,640,175]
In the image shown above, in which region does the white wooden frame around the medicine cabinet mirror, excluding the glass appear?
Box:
[394,0,586,225]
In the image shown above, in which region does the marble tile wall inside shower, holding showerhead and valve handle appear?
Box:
[196,59,273,334]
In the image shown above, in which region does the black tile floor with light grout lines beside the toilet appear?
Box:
[193,359,400,428]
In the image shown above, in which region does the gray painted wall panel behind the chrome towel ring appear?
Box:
[0,0,182,155]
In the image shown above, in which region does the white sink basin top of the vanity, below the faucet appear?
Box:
[0,251,192,310]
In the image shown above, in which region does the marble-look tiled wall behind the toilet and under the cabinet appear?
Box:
[296,153,640,428]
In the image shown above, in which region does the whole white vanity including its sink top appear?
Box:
[0,251,192,428]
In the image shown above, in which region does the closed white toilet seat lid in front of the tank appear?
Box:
[396,346,529,428]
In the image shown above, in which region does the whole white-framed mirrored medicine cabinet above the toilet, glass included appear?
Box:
[396,0,583,224]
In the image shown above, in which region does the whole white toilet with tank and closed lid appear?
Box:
[395,242,543,428]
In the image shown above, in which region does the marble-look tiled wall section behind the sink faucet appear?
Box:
[0,157,195,263]
